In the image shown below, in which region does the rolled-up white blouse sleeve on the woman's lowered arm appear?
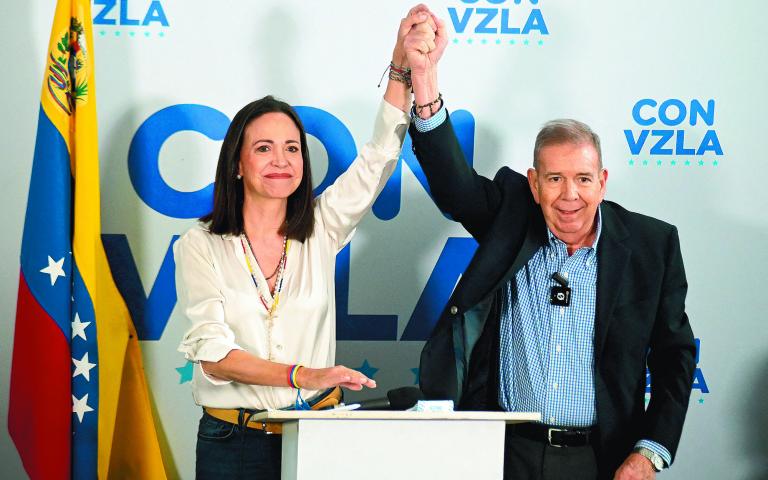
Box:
[173,229,243,384]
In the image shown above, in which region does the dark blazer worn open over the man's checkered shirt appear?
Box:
[410,115,696,478]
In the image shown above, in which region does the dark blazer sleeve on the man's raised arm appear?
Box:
[410,112,502,239]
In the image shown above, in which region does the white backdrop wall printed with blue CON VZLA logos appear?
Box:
[0,0,768,479]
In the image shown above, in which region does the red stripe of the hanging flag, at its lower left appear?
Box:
[8,273,72,480]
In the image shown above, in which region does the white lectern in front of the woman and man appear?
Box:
[253,410,541,480]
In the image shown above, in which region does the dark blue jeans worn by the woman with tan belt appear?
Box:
[195,412,283,480]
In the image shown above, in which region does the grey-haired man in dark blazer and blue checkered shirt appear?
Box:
[405,10,695,479]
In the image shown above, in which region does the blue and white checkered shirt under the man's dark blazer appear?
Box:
[411,106,672,466]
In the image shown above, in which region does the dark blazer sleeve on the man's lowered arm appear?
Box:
[642,227,696,461]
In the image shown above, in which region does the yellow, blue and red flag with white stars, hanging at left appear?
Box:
[8,0,166,480]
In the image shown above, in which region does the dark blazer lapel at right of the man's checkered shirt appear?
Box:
[595,202,631,360]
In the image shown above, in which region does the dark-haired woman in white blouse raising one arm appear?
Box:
[174,6,434,480]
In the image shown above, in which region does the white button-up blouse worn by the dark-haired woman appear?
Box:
[174,100,410,409]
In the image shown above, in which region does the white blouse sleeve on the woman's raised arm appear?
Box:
[317,95,410,250]
